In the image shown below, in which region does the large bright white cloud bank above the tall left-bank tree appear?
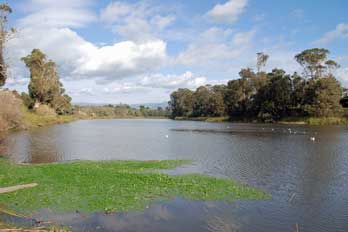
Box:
[6,0,170,86]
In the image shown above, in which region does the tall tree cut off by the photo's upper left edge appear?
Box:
[0,4,15,87]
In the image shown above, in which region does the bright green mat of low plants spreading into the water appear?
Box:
[0,159,269,213]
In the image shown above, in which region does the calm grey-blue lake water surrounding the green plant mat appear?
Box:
[0,120,348,232]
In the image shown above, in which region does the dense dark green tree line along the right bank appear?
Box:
[168,48,343,122]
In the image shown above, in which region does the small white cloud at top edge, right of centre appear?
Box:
[207,0,248,24]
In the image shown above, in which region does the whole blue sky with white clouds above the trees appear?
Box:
[5,0,348,104]
